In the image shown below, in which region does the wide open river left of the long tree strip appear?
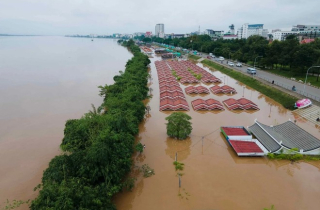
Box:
[0,36,132,209]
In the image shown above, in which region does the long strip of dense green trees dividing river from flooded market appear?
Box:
[31,40,150,210]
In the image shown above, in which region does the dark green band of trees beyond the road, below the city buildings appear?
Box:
[140,35,320,82]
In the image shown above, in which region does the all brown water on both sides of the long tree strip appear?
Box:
[0,37,320,210]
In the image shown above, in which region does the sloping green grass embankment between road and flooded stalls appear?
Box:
[201,60,298,110]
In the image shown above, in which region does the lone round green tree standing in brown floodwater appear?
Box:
[166,112,192,139]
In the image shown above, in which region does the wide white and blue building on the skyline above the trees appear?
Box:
[238,23,268,39]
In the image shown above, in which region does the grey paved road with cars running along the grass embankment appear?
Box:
[195,54,320,102]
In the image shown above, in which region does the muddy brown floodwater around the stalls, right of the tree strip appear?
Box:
[114,57,320,210]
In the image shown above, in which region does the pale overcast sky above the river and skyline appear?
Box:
[0,0,320,35]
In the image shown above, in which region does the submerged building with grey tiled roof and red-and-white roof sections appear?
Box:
[220,120,320,156]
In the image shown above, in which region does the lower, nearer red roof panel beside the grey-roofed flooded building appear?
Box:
[229,140,264,156]
